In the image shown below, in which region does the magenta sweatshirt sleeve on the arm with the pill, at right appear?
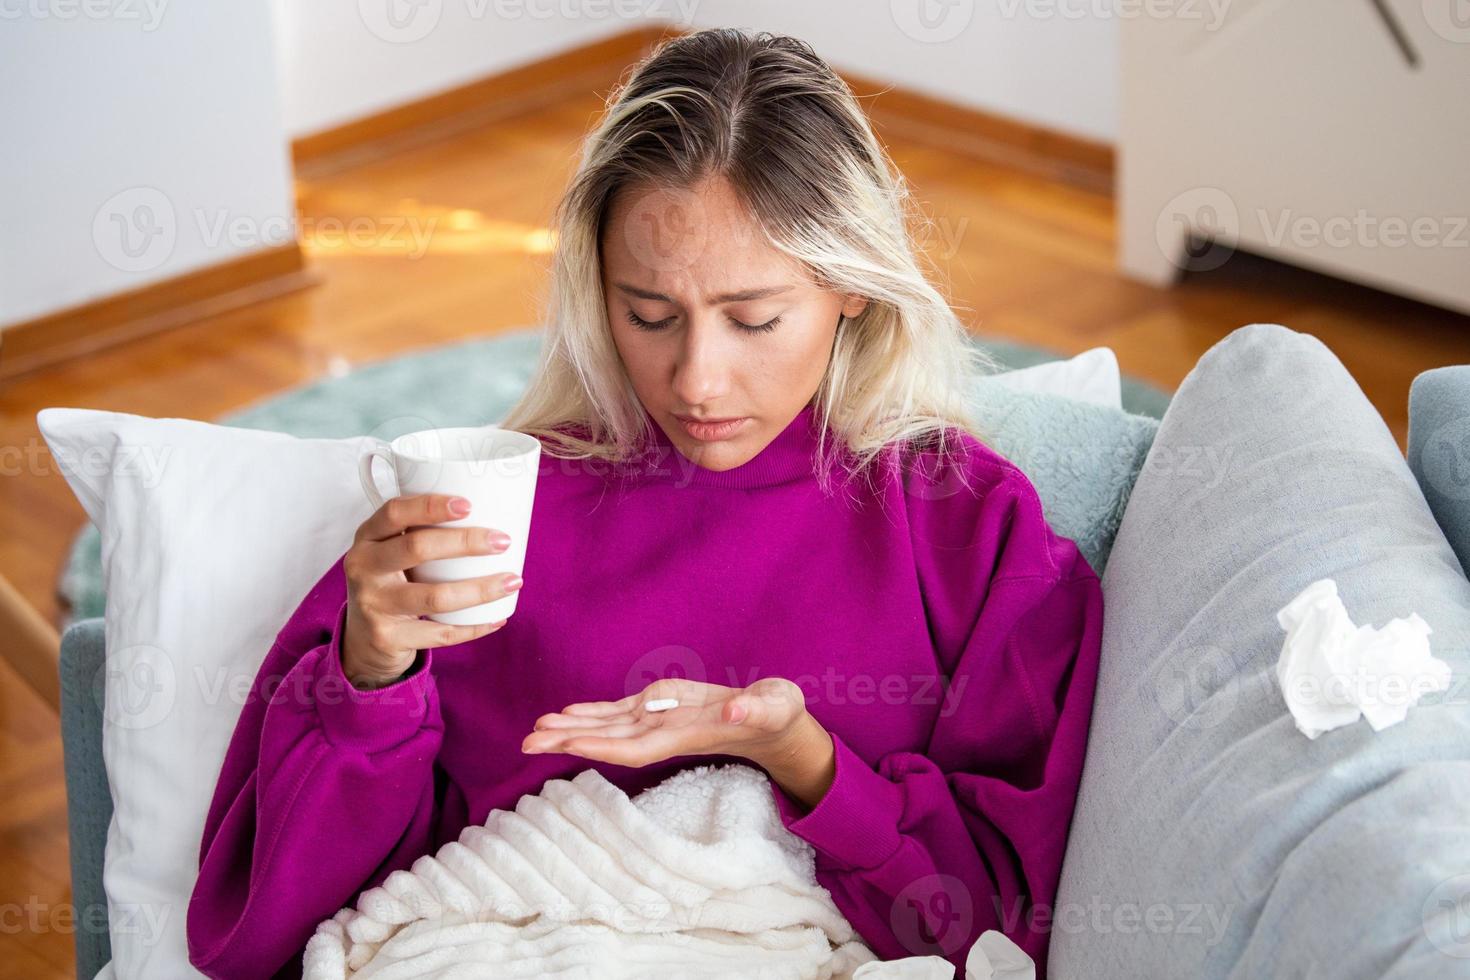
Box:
[772,455,1103,977]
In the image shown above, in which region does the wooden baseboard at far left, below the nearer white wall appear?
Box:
[0,242,316,381]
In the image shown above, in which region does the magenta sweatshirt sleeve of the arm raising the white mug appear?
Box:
[187,558,442,980]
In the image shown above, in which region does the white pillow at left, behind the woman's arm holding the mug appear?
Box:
[37,408,372,980]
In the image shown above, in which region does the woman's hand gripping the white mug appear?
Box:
[343,494,520,689]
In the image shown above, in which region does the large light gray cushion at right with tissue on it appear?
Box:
[1047,323,1470,980]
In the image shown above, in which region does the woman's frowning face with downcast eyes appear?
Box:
[601,178,867,470]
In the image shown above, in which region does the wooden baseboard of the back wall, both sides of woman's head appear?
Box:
[291,25,1114,195]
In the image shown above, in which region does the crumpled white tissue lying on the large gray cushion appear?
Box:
[1276,579,1451,739]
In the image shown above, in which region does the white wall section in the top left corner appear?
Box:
[0,0,294,332]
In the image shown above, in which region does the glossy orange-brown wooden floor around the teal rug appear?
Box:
[0,65,1470,980]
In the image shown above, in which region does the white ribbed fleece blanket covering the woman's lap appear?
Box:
[303,764,1033,980]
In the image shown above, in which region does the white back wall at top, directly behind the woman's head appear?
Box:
[275,0,1117,141]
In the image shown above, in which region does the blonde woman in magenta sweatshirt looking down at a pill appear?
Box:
[188,29,1103,977]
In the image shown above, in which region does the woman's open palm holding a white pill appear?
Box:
[520,677,833,804]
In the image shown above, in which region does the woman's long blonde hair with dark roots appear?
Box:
[501,28,997,488]
